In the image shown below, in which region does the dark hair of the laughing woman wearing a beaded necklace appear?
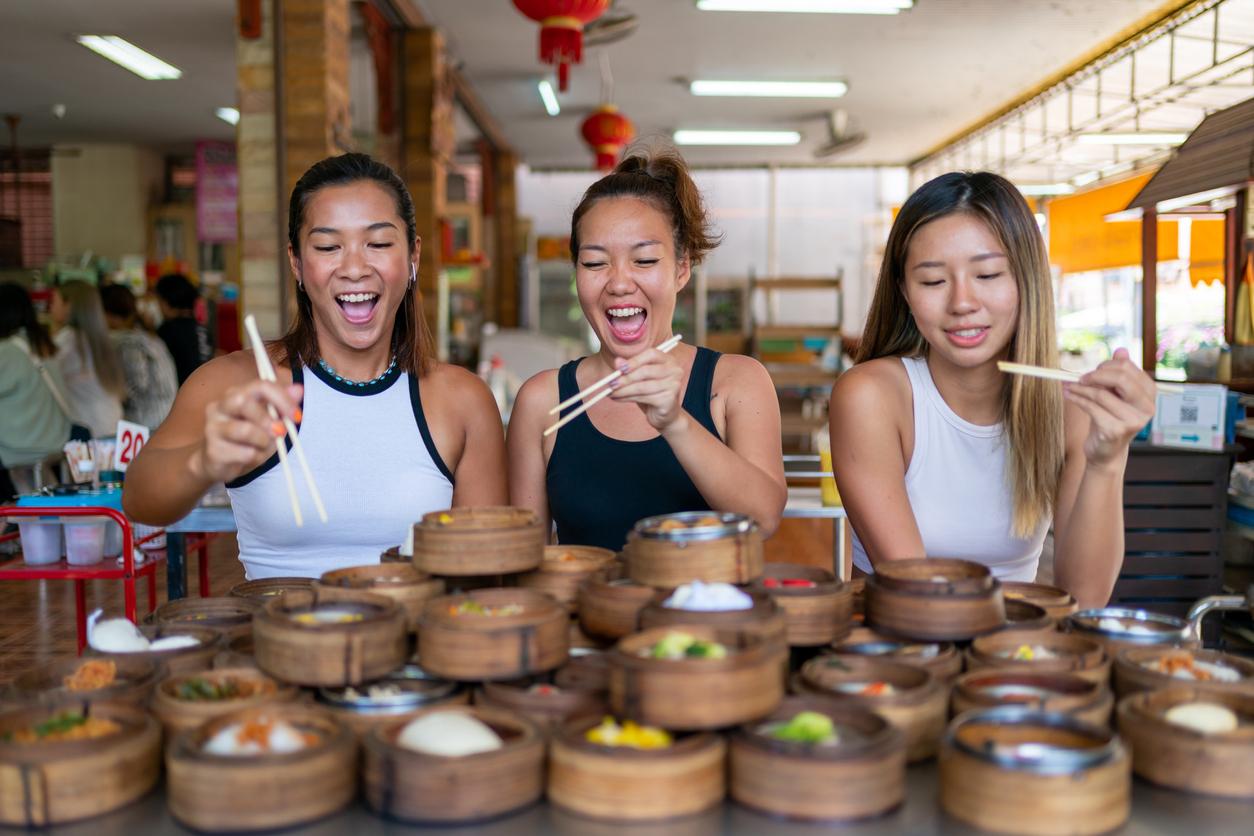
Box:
[280,154,435,377]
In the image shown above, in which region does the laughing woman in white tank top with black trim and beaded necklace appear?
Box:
[122,154,508,579]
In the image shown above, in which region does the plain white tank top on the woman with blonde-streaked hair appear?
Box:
[854,357,1050,582]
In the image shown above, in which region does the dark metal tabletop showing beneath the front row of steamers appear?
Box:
[44,763,1254,836]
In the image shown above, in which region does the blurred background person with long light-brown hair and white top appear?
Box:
[48,281,127,439]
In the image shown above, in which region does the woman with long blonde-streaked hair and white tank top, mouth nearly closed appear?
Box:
[830,172,1155,608]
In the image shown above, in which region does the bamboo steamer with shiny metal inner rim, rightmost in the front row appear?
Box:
[939,707,1132,836]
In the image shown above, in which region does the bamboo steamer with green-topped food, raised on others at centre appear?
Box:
[609,624,788,731]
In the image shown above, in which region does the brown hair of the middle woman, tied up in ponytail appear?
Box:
[571,145,722,264]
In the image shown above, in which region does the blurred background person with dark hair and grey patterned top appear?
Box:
[100,285,178,430]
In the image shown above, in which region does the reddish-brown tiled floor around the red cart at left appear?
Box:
[0,534,243,684]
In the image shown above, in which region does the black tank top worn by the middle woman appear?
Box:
[544,347,722,551]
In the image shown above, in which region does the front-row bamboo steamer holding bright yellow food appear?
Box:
[548,714,727,822]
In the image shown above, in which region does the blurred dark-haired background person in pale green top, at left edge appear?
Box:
[0,282,70,501]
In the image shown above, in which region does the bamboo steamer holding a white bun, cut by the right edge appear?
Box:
[1117,683,1254,800]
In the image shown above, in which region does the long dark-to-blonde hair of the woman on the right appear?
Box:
[856,172,1065,538]
